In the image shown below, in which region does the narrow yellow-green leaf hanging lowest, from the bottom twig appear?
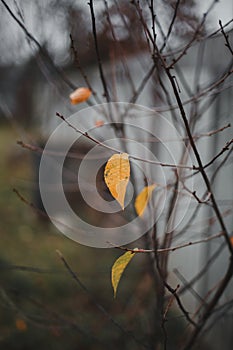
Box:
[112,252,135,298]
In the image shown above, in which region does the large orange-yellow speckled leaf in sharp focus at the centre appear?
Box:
[104,153,130,210]
